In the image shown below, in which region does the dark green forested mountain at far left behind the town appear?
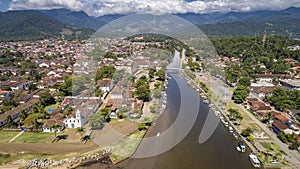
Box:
[0,10,94,41]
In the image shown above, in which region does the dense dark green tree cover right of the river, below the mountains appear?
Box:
[211,36,300,83]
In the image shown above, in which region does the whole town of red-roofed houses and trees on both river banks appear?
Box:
[0,35,300,169]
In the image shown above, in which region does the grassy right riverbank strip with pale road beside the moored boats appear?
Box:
[189,70,293,168]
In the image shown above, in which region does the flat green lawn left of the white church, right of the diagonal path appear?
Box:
[15,132,54,143]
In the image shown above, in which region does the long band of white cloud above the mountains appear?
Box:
[9,0,300,16]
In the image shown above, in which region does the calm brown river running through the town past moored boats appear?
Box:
[82,51,253,169]
